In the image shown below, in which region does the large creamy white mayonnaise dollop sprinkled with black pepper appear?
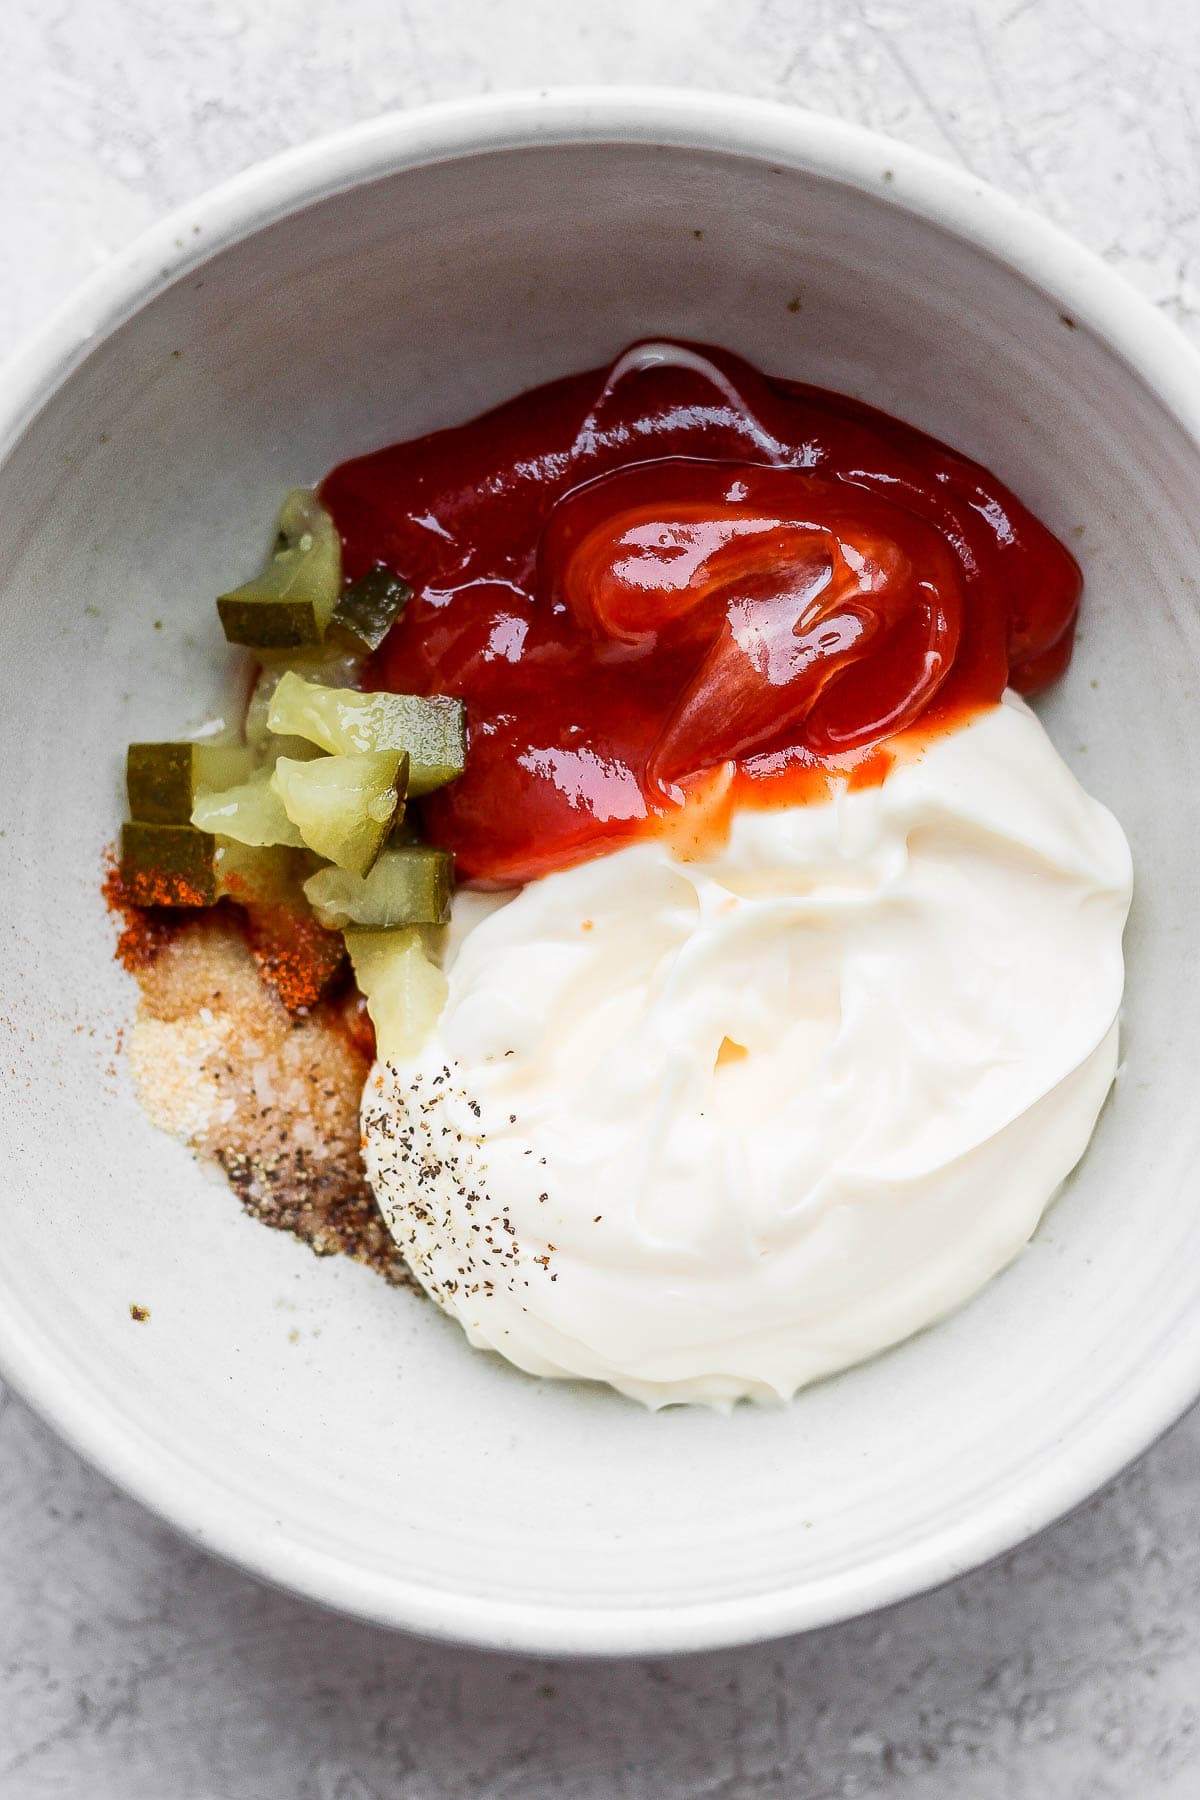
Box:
[363,695,1132,1406]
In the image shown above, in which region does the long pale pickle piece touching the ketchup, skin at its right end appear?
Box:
[266,671,466,797]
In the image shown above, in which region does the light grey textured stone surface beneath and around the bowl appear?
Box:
[0,0,1200,1800]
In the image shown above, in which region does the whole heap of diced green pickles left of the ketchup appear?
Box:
[121,488,466,1022]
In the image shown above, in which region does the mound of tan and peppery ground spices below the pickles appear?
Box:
[130,911,412,1285]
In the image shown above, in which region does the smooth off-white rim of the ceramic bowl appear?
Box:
[0,86,1200,1656]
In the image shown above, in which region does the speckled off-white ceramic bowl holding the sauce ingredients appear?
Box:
[0,90,1200,1652]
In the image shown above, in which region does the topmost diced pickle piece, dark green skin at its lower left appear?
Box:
[216,488,342,650]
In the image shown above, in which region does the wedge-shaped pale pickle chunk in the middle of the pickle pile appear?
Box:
[270,751,408,875]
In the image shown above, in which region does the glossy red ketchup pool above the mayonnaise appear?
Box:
[322,344,1081,887]
